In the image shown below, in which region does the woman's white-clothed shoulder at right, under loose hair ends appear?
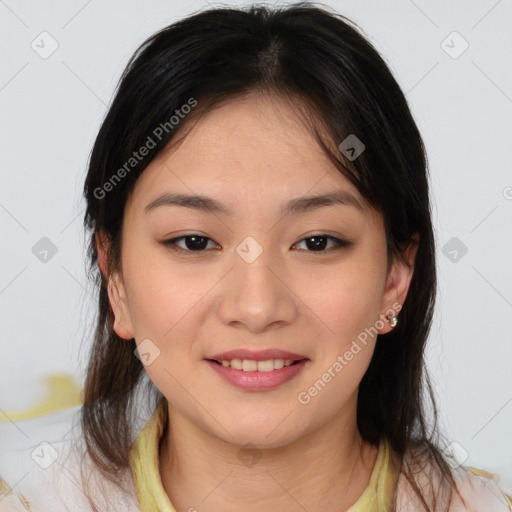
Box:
[397,446,512,512]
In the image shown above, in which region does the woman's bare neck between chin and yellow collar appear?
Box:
[160,396,378,512]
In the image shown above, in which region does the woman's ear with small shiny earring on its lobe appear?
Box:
[379,233,419,334]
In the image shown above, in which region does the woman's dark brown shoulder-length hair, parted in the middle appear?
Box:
[81,2,468,511]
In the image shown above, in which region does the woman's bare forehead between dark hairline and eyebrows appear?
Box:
[128,95,365,217]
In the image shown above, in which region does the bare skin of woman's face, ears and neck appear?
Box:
[98,94,417,512]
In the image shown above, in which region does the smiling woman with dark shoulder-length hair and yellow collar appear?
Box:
[3,2,512,512]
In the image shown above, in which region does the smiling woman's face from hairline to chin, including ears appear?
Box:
[103,95,411,447]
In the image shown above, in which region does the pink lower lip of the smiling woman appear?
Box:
[206,359,308,391]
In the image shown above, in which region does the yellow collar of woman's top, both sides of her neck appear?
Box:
[130,399,398,512]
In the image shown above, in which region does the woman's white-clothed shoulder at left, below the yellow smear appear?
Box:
[0,407,140,512]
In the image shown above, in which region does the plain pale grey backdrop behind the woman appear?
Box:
[0,0,512,488]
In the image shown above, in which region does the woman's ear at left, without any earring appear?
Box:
[96,232,134,340]
